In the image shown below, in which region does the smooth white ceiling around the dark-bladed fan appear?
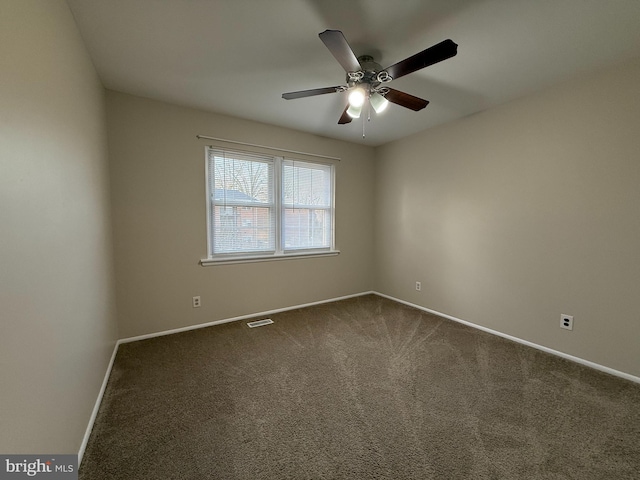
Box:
[68,0,640,145]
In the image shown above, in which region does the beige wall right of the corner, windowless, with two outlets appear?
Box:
[376,58,640,376]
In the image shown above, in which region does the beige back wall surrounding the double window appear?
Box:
[107,92,374,338]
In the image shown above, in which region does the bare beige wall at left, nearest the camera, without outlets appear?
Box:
[0,0,117,454]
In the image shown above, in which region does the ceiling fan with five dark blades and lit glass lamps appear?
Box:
[282,30,458,125]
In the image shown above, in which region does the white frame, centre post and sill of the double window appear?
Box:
[200,146,340,266]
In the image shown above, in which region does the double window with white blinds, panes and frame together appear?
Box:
[207,147,335,261]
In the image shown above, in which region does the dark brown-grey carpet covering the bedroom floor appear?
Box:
[80,295,640,480]
